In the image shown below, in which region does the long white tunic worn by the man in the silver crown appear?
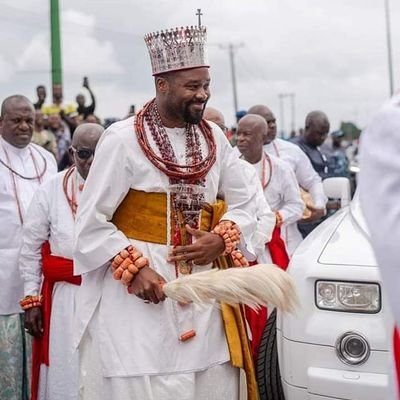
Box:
[74,118,264,377]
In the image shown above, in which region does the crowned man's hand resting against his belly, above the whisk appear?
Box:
[168,225,225,265]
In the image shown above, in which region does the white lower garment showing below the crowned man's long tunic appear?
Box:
[79,318,239,400]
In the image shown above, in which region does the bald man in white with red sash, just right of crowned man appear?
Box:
[237,114,304,357]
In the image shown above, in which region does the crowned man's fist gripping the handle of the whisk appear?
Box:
[128,266,166,304]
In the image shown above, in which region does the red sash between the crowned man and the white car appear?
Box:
[245,226,289,360]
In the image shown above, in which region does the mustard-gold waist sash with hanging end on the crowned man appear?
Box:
[111,189,258,400]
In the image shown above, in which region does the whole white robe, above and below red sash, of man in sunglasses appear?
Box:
[19,169,84,400]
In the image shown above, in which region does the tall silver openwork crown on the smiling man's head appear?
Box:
[144,26,210,75]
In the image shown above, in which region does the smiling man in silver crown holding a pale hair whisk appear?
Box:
[74,27,266,400]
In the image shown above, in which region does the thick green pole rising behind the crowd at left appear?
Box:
[50,0,62,86]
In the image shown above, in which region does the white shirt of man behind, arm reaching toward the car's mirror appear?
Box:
[264,138,328,208]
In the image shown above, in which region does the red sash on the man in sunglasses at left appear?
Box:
[31,242,81,400]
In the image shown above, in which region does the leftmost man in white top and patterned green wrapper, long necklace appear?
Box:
[0,95,57,400]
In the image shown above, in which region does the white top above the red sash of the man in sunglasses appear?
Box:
[19,170,84,296]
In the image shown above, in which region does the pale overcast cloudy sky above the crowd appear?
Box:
[0,0,400,130]
